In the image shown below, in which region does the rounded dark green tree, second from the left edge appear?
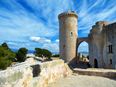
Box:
[16,48,28,62]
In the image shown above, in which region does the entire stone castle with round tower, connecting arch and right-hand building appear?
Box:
[58,11,116,68]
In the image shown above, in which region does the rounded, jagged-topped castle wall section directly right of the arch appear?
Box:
[89,21,105,68]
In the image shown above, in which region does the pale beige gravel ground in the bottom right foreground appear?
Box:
[48,74,116,87]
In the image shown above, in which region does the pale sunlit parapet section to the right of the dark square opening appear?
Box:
[33,60,72,87]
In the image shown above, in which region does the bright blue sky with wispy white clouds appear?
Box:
[0,0,116,52]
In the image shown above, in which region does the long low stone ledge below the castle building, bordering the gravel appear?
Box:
[74,68,116,79]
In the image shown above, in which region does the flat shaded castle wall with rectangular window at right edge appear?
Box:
[104,23,116,68]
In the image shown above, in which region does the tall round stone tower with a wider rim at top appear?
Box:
[58,11,77,63]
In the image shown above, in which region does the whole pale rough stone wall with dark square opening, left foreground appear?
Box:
[0,59,72,87]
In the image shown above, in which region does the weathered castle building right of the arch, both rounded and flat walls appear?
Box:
[88,21,116,68]
